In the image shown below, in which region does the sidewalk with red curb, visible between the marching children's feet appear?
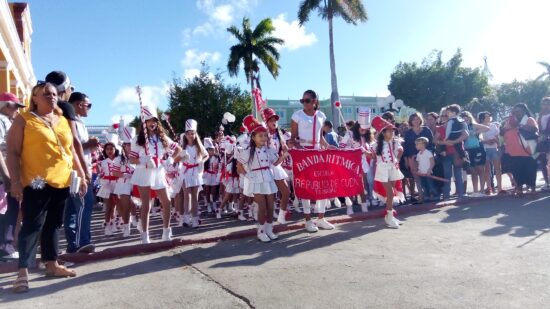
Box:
[0,173,550,273]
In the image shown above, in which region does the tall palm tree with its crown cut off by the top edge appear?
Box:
[298,0,368,126]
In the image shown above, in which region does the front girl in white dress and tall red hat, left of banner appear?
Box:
[237,115,288,242]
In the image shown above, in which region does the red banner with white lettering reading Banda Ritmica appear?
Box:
[289,149,364,200]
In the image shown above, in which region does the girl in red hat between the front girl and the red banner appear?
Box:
[262,107,290,224]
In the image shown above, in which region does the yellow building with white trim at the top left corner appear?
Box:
[0,0,36,104]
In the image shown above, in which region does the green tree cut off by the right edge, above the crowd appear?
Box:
[496,79,550,112]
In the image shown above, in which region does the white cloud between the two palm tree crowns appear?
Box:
[273,14,317,50]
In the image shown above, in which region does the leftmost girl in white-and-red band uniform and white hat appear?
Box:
[97,134,120,236]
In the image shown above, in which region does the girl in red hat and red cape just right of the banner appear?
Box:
[372,116,405,228]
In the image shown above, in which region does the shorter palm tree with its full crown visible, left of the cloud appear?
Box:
[227,17,284,116]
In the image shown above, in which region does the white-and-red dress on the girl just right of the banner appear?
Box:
[373,139,405,202]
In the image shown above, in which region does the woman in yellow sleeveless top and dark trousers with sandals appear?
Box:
[7,83,87,293]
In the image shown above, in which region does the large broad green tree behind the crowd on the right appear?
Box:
[388,50,490,112]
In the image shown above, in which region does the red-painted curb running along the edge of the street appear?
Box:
[0,192,541,274]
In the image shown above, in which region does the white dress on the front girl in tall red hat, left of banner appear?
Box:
[237,146,279,194]
